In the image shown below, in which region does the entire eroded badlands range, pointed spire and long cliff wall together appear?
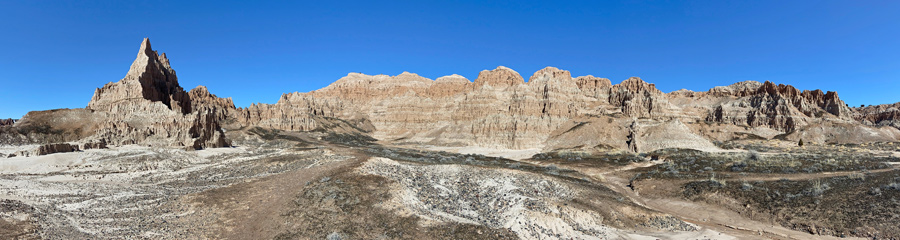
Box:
[0,39,900,152]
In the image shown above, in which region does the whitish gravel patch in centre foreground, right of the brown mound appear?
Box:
[359,158,694,239]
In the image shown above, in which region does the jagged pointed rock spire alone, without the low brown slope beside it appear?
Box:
[87,39,234,149]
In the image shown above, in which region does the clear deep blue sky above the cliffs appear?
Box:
[0,0,900,118]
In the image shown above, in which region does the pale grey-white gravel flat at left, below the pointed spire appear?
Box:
[0,136,343,239]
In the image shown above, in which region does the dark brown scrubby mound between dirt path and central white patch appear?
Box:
[275,173,516,239]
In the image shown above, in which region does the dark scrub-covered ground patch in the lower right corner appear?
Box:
[683,170,900,239]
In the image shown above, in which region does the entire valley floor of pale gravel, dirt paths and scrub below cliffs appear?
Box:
[0,131,900,239]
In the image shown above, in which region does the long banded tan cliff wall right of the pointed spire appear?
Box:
[234,67,891,152]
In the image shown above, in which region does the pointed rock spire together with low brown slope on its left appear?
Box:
[0,39,234,152]
